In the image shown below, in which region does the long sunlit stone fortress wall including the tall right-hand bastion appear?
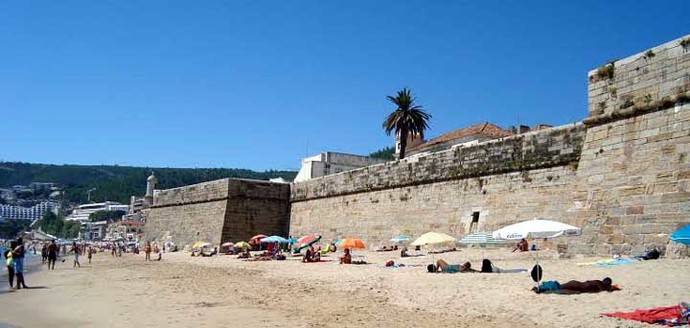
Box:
[290,36,690,254]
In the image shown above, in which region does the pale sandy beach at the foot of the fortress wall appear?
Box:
[0,249,690,327]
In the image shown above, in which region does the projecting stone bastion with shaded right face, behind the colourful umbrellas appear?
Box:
[144,179,290,246]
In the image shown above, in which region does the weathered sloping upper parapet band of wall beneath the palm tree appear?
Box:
[291,124,585,203]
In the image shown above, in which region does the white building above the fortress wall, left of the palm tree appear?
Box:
[295,152,387,182]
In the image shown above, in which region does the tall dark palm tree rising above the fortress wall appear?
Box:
[383,88,431,159]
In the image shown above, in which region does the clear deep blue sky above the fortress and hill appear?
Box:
[0,0,690,170]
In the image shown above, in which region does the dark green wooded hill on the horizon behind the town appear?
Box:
[0,162,297,204]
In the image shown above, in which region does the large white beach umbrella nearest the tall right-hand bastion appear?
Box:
[492,219,582,240]
